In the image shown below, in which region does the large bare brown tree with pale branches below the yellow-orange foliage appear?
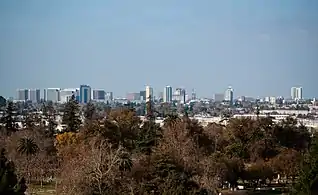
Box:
[60,138,130,195]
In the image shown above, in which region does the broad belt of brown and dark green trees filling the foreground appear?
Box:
[0,96,318,195]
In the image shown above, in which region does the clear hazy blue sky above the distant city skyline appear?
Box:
[0,0,318,98]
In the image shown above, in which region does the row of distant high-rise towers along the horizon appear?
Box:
[10,85,315,104]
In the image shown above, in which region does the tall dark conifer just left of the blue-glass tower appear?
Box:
[63,95,82,132]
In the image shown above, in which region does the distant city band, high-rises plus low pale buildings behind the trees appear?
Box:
[6,85,318,130]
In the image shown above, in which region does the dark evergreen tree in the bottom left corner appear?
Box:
[0,149,27,195]
